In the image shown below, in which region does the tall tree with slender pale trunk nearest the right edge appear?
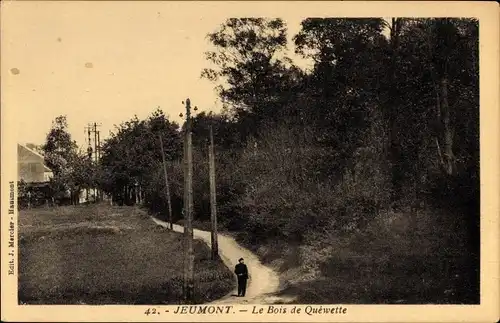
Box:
[413,18,478,176]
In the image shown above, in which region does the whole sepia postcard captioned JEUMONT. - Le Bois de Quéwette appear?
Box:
[1,1,498,321]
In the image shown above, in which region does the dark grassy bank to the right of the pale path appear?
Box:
[239,211,479,304]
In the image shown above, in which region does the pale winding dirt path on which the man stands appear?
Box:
[152,217,286,304]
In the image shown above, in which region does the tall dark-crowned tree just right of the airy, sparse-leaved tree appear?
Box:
[294,18,386,173]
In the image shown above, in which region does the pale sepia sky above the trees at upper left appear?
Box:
[2,2,312,146]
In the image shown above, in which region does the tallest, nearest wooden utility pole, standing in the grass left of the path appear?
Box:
[180,99,198,303]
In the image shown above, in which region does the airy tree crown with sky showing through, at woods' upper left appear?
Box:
[202,18,299,126]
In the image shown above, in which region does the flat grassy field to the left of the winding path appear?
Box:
[19,204,235,304]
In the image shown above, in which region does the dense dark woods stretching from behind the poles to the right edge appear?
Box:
[37,18,479,301]
